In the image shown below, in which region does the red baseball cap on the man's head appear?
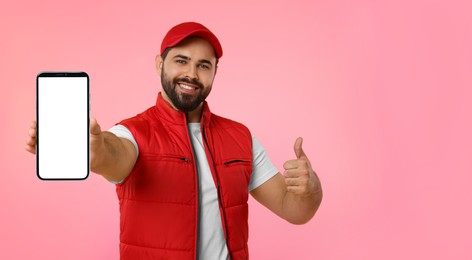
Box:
[161,22,223,58]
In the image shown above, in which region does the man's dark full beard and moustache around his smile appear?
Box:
[161,69,212,113]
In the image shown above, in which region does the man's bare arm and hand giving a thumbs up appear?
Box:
[251,138,323,224]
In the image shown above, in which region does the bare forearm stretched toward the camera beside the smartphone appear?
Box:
[91,131,136,181]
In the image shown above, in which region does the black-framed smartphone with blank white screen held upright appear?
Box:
[36,72,90,180]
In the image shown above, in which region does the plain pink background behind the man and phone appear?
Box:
[0,0,472,259]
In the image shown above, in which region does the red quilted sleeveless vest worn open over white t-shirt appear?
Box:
[116,93,252,260]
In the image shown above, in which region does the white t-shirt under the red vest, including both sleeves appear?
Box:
[108,123,278,259]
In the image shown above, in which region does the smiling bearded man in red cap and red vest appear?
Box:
[26,22,322,259]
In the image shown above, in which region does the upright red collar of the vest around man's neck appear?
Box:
[156,92,211,126]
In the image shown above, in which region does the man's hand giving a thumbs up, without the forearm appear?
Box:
[283,137,321,196]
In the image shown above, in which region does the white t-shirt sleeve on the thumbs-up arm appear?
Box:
[248,135,279,191]
